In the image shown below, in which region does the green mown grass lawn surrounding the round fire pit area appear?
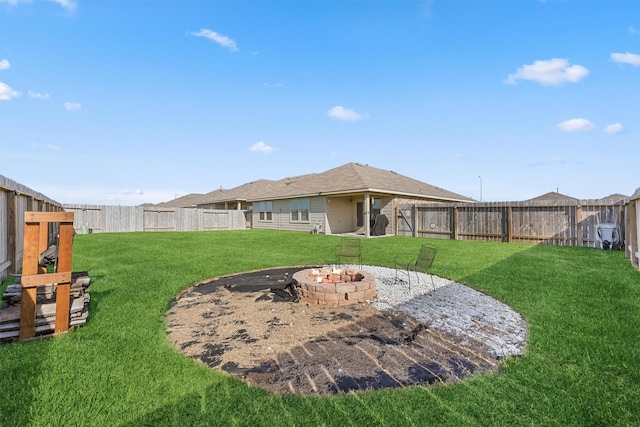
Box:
[0,230,640,427]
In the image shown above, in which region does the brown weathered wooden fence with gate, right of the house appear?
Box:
[396,200,625,247]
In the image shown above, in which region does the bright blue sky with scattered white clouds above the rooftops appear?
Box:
[0,0,640,205]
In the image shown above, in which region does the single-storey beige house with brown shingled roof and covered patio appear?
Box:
[196,163,475,237]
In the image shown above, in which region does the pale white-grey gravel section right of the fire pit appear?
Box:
[348,265,528,358]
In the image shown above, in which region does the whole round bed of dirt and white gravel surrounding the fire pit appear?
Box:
[166,265,528,395]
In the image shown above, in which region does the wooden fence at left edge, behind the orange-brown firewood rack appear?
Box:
[0,175,62,279]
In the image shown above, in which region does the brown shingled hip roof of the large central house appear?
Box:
[194,163,475,205]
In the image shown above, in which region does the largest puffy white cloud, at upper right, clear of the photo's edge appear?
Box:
[505,58,589,86]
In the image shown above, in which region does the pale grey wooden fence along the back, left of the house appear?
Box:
[64,205,247,234]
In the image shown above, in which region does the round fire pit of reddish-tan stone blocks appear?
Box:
[292,267,376,305]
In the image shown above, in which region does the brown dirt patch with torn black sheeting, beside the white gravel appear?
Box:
[167,266,498,394]
